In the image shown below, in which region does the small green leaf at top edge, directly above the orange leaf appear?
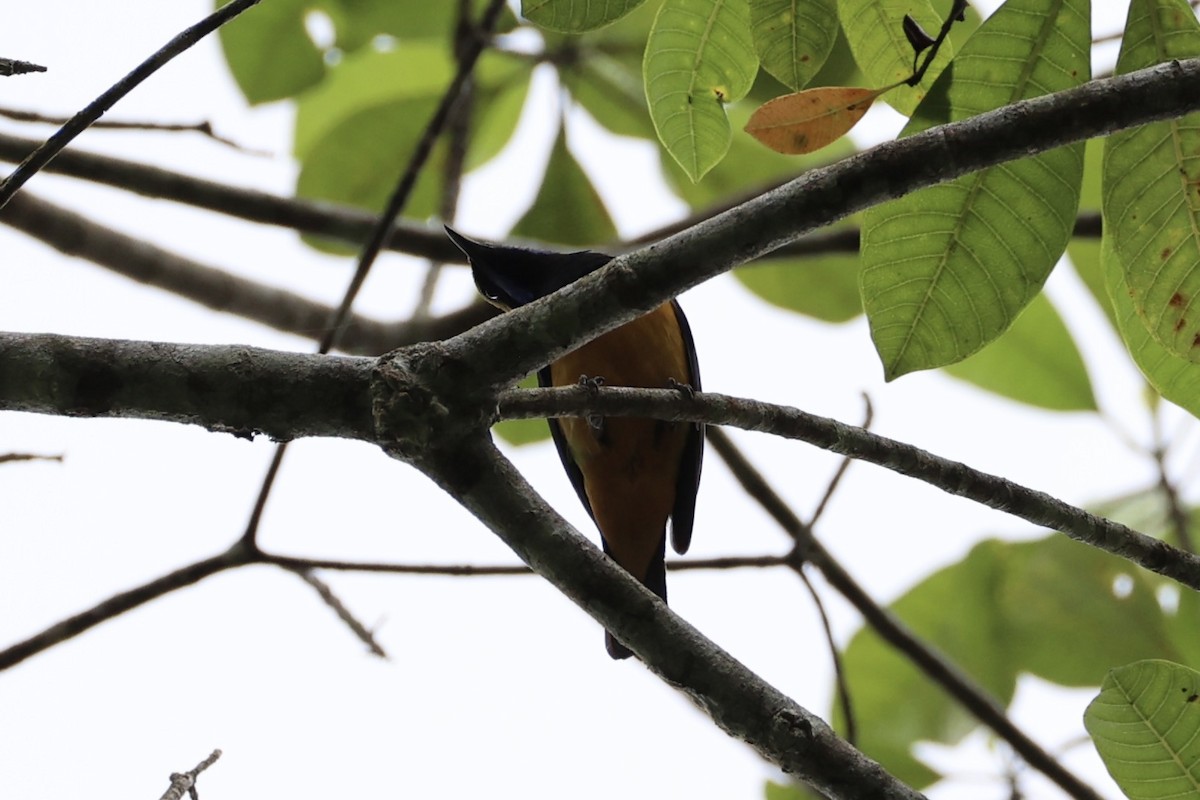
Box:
[750,0,839,91]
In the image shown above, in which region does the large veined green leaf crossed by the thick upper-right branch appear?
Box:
[862,0,1091,380]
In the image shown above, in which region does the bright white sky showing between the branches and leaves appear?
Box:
[0,0,1171,800]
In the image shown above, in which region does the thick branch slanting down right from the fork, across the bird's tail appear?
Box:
[415,438,922,799]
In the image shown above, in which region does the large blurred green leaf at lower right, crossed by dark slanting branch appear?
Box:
[833,535,1180,787]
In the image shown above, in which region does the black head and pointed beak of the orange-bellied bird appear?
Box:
[446,225,612,311]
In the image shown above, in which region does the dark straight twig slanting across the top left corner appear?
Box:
[0,0,259,209]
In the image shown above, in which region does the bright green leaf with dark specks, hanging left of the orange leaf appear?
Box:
[642,0,758,181]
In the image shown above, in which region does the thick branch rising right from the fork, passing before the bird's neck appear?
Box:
[446,59,1200,385]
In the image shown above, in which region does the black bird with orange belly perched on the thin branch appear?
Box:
[445,227,704,658]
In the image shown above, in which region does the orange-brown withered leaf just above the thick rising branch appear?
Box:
[745,86,886,156]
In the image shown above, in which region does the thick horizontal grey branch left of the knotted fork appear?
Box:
[0,333,376,441]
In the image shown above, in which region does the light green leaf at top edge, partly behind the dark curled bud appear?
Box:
[838,0,954,116]
